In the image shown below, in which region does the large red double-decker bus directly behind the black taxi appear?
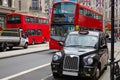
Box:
[49,2,103,50]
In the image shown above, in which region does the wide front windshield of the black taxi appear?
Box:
[65,34,98,48]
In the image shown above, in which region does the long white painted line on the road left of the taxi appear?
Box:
[0,63,50,80]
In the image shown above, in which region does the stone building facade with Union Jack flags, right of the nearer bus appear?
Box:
[78,0,120,34]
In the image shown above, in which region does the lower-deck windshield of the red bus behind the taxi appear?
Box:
[50,25,75,41]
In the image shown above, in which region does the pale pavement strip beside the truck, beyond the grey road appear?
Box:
[0,43,49,59]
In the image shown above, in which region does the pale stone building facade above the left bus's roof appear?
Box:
[14,0,52,17]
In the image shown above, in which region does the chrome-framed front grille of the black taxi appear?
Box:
[63,55,79,71]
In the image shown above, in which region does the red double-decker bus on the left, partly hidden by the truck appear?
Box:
[6,13,50,44]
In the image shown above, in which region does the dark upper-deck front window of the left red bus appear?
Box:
[7,15,21,24]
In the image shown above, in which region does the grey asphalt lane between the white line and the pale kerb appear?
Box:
[0,51,52,80]
